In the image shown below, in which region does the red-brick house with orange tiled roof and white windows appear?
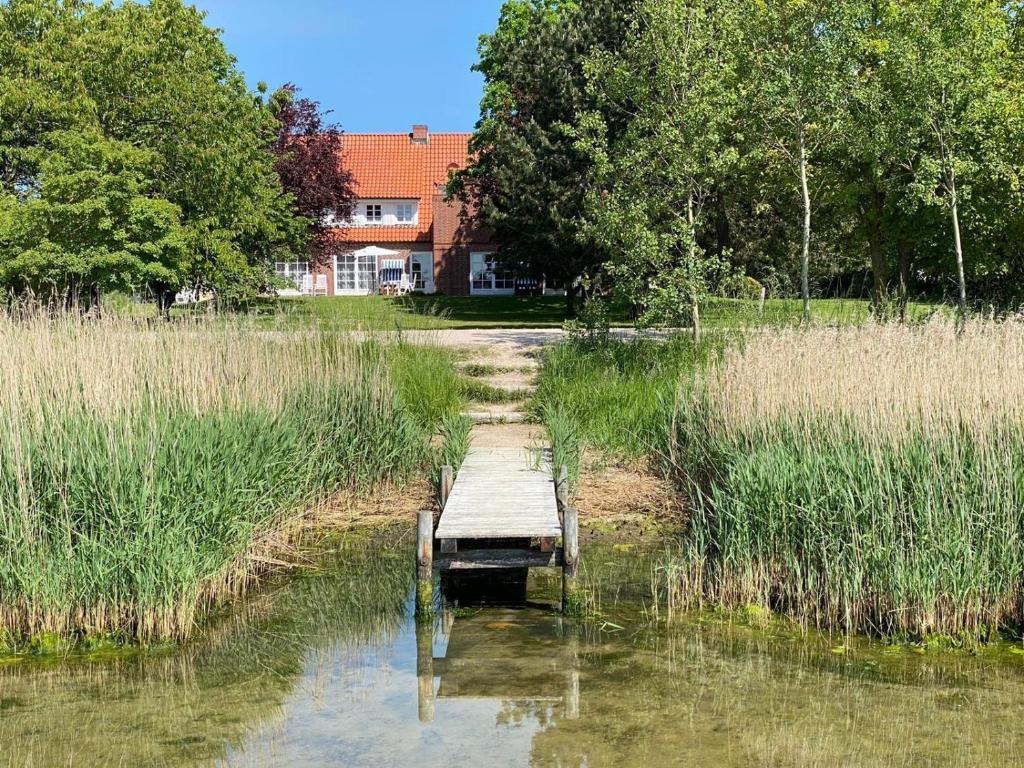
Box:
[276,125,515,296]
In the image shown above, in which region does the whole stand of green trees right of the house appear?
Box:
[475,0,1024,325]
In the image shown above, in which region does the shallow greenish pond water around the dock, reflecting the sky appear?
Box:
[0,545,1024,768]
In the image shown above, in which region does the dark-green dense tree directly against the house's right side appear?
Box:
[451,0,636,313]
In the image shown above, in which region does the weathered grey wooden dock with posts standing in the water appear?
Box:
[417,447,579,616]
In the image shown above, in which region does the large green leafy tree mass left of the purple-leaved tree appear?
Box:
[0,0,305,303]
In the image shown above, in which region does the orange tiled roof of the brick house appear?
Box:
[342,133,472,243]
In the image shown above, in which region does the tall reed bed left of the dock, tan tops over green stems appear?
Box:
[0,317,431,642]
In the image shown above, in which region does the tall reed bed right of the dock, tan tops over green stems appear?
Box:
[669,321,1024,638]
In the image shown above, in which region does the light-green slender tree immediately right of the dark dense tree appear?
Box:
[590,0,739,341]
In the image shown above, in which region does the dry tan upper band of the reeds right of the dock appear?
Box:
[703,321,1024,439]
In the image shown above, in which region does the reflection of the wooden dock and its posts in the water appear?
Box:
[417,609,580,722]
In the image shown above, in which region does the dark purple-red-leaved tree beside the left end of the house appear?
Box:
[269,84,356,261]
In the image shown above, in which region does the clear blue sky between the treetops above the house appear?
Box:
[194,0,502,133]
